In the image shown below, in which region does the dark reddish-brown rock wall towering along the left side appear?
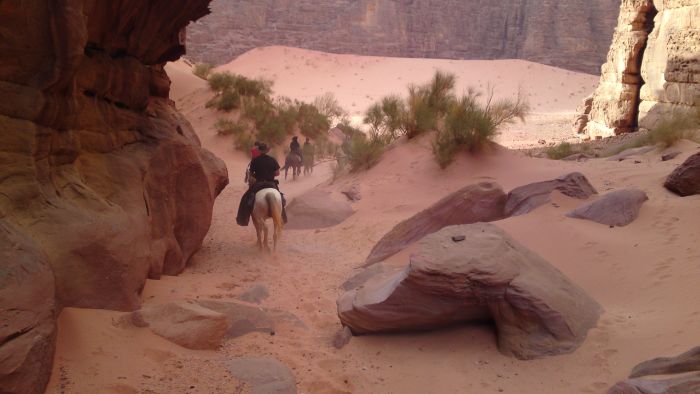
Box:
[0,0,228,394]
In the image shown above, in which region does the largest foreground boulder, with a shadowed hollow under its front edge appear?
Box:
[338,223,601,359]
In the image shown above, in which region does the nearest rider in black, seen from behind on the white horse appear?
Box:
[236,143,287,226]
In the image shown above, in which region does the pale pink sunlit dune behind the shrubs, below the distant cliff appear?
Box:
[217,46,598,147]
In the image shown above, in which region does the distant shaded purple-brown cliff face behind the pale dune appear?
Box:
[187,0,620,74]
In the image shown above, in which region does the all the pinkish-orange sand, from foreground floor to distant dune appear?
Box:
[48,48,700,393]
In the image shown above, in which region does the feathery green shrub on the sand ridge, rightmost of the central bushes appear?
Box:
[433,89,529,168]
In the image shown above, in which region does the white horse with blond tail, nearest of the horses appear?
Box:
[251,188,284,251]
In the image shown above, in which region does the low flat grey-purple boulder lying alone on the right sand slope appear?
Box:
[566,189,649,226]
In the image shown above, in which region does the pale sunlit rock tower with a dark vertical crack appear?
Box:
[586,0,700,138]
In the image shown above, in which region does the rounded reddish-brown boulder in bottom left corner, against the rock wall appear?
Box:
[0,219,56,394]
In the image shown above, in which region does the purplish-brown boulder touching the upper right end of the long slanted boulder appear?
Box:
[504,172,598,217]
